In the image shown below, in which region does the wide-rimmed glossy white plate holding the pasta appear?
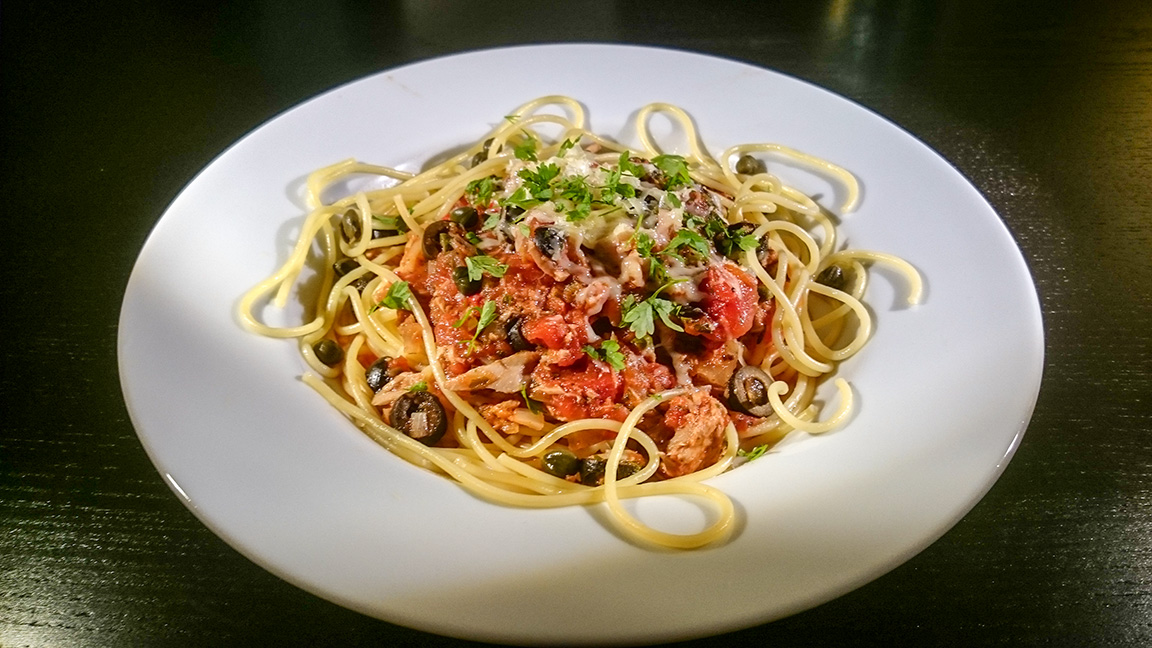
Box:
[119,45,1043,643]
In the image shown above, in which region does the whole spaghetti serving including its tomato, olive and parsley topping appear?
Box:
[238,96,920,549]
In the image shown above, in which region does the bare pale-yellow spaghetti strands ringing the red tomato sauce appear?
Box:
[237,96,923,549]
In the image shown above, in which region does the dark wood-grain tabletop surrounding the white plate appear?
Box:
[0,0,1152,648]
